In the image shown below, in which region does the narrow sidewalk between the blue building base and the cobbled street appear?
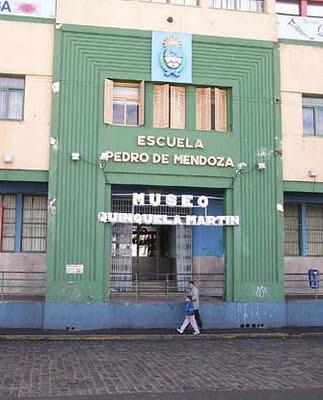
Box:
[0,327,323,341]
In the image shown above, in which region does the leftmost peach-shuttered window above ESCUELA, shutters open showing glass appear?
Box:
[104,79,144,126]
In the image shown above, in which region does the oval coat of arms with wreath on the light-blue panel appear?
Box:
[160,36,185,76]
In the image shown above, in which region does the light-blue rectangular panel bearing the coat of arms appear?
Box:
[151,32,192,83]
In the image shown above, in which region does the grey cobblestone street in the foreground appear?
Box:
[0,337,323,400]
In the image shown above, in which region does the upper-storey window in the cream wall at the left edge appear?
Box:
[0,76,25,121]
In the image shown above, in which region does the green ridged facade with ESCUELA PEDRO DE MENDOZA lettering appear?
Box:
[46,25,284,303]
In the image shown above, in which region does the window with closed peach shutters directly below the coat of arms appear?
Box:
[153,84,185,129]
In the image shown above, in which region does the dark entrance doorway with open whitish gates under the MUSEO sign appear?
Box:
[110,195,192,292]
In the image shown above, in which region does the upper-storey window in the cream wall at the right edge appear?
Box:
[303,97,323,136]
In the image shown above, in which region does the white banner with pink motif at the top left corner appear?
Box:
[0,0,56,18]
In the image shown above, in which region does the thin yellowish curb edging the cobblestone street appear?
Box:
[0,332,323,342]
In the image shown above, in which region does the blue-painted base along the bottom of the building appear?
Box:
[0,300,323,331]
